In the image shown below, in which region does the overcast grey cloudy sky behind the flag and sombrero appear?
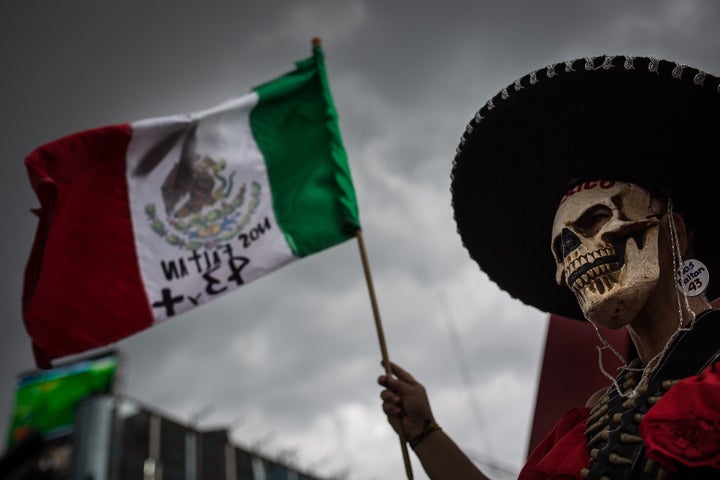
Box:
[0,0,720,480]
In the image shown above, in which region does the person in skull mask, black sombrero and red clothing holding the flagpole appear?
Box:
[378,55,720,480]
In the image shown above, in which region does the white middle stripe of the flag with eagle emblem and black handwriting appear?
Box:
[127,92,295,322]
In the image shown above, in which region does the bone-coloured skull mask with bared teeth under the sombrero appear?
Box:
[551,181,665,328]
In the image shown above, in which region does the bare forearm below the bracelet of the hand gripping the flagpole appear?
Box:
[413,430,488,480]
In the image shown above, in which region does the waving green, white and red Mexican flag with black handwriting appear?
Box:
[22,42,360,368]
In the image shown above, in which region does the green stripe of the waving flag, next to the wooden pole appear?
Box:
[250,45,360,257]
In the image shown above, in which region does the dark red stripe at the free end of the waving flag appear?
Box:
[22,124,153,367]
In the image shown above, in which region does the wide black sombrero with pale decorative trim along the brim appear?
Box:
[451,56,720,319]
